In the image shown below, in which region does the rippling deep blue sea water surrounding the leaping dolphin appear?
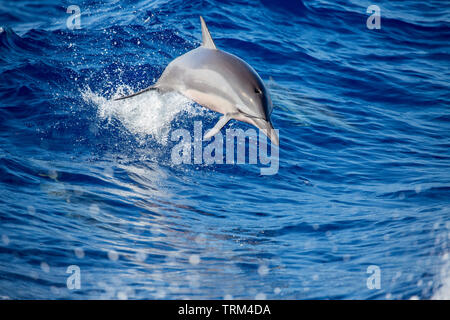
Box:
[0,0,450,299]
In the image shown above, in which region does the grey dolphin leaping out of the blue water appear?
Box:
[115,16,279,145]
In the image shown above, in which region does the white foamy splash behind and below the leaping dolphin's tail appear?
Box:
[81,85,205,145]
